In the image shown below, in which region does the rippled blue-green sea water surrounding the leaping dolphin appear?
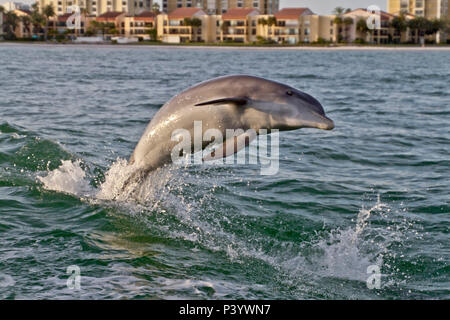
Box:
[0,45,450,299]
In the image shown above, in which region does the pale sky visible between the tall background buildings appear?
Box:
[0,0,387,14]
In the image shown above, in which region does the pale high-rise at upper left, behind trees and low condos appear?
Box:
[39,0,153,16]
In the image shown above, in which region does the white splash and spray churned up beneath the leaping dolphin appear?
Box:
[34,159,413,298]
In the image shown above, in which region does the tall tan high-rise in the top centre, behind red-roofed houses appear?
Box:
[162,0,280,14]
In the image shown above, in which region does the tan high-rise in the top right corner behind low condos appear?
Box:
[387,0,450,19]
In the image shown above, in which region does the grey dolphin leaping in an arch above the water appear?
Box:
[129,75,334,176]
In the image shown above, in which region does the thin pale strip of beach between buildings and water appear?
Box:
[0,41,450,51]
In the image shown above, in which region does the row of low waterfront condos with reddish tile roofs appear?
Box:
[0,4,447,44]
